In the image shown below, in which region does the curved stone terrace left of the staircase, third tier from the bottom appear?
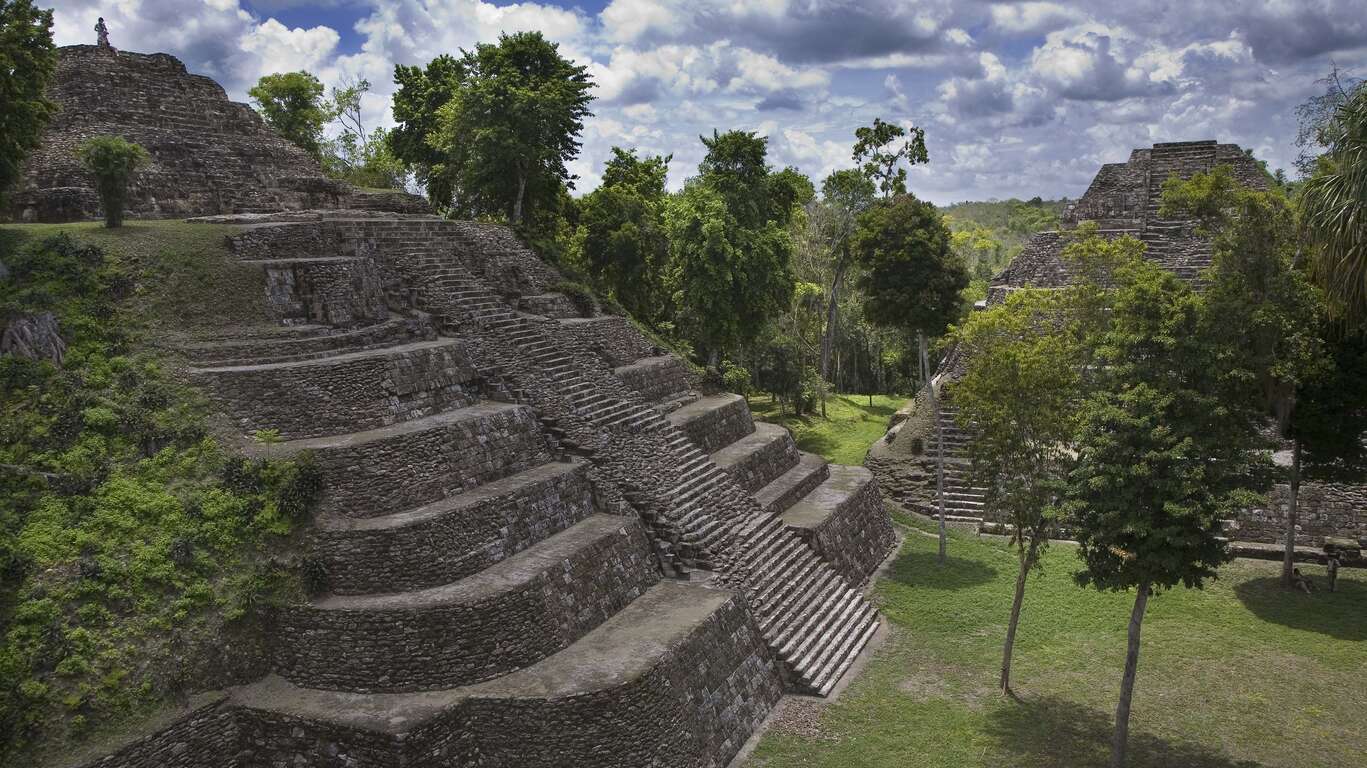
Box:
[319,459,593,594]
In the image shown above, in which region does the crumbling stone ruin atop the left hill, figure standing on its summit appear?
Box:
[0,45,428,221]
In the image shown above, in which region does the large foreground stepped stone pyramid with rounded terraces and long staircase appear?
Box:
[32,49,895,768]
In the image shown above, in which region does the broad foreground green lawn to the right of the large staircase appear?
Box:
[745,513,1367,768]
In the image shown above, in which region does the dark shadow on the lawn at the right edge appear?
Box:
[1234,571,1367,640]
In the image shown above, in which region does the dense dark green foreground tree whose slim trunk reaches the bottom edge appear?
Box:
[1068,236,1270,768]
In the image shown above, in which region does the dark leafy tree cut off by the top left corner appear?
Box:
[0,0,57,206]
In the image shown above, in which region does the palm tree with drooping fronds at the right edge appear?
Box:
[1300,87,1367,324]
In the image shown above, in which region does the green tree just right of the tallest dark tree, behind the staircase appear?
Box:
[580,146,670,324]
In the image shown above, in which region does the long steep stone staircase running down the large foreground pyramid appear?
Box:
[369,241,893,694]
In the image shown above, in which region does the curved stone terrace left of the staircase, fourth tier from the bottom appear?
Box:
[250,402,552,518]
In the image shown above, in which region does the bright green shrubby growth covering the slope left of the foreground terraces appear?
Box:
[0,232,320,764]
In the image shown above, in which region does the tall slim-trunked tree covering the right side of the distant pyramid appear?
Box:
[1162,165,1327,586]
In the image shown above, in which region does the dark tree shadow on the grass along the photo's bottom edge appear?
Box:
[986,696,1260,768]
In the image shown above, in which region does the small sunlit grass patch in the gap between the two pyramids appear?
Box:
[750,395,906,465]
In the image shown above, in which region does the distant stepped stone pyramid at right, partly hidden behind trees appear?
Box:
[865,141,1367,553]
